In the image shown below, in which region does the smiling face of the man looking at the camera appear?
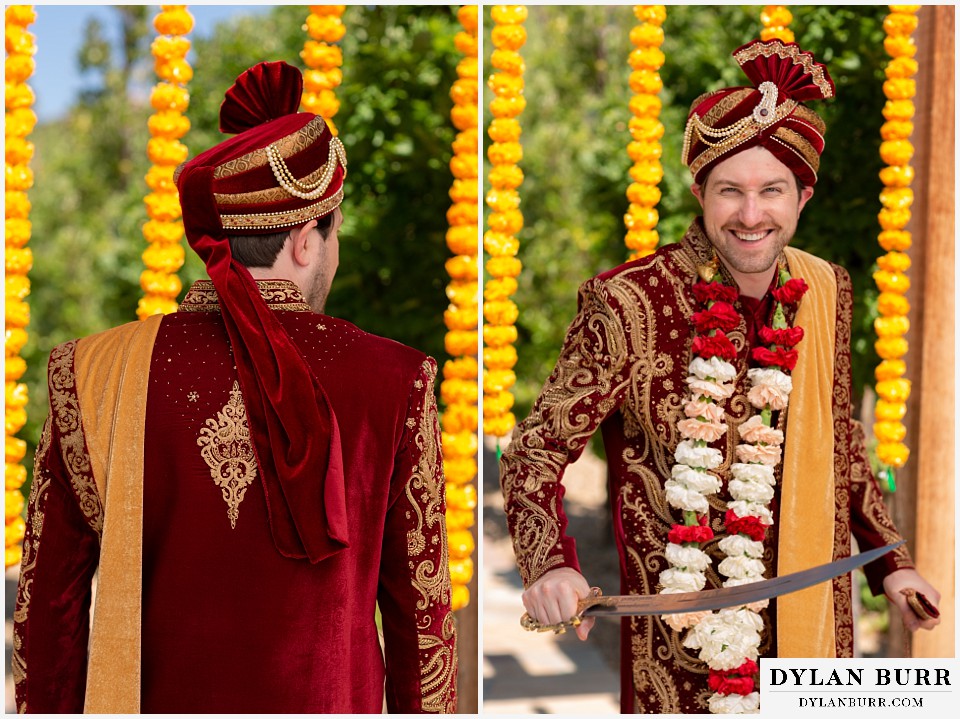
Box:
[691,147,813,297]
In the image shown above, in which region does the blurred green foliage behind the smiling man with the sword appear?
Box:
[484,5,888,418]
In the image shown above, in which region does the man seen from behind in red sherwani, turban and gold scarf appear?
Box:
[13,62,457,714]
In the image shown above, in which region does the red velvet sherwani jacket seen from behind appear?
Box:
[14,281,456,713]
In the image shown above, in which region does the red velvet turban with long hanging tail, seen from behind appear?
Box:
[174,62,348,562]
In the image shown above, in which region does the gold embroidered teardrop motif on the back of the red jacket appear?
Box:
[197,380,257,529]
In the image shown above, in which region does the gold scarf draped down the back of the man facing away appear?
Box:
[74,315,162,714]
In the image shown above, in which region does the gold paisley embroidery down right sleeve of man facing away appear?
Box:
[405,360,457,713]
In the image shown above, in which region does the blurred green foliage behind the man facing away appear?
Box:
[21,6,462,478]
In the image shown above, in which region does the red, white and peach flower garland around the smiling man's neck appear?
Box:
[660,261,807,714]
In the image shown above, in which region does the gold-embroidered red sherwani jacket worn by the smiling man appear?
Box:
[501,220,912,713]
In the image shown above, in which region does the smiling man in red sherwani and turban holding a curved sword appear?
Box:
[501,40,939,713]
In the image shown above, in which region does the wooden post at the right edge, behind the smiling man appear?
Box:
[897,5,956,657]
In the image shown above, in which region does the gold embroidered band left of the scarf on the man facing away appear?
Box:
[49,340,103,537]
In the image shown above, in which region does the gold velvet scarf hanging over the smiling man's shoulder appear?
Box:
[777,247,837,657]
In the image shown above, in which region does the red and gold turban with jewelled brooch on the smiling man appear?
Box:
[682,40,834,187]
